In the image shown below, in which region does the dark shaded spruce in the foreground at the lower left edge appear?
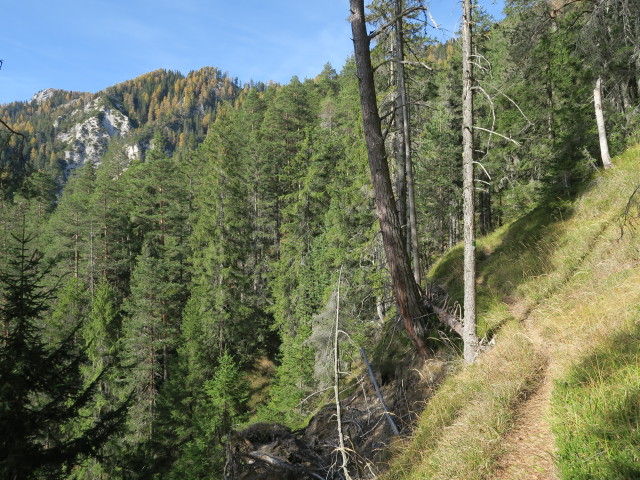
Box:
[0,223,126,479]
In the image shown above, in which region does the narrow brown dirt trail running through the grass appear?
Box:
[493,308,559,480]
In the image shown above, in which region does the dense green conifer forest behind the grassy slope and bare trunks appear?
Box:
[0,0,640,479]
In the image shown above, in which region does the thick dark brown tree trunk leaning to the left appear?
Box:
[350,0,433,358]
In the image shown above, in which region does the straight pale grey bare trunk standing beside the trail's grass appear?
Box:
[462,0,478,363]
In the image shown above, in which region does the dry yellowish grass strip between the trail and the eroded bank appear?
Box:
[386,321,543,479]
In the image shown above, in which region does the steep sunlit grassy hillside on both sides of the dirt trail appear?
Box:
[385,147,640,480]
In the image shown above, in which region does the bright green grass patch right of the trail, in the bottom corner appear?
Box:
[553,322,640,480]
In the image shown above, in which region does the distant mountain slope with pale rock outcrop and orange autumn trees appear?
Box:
[2,67,240,186]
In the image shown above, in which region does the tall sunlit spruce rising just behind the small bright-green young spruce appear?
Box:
[191,107,267,362]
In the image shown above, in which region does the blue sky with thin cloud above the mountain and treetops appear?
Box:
[0,0,503,103]
